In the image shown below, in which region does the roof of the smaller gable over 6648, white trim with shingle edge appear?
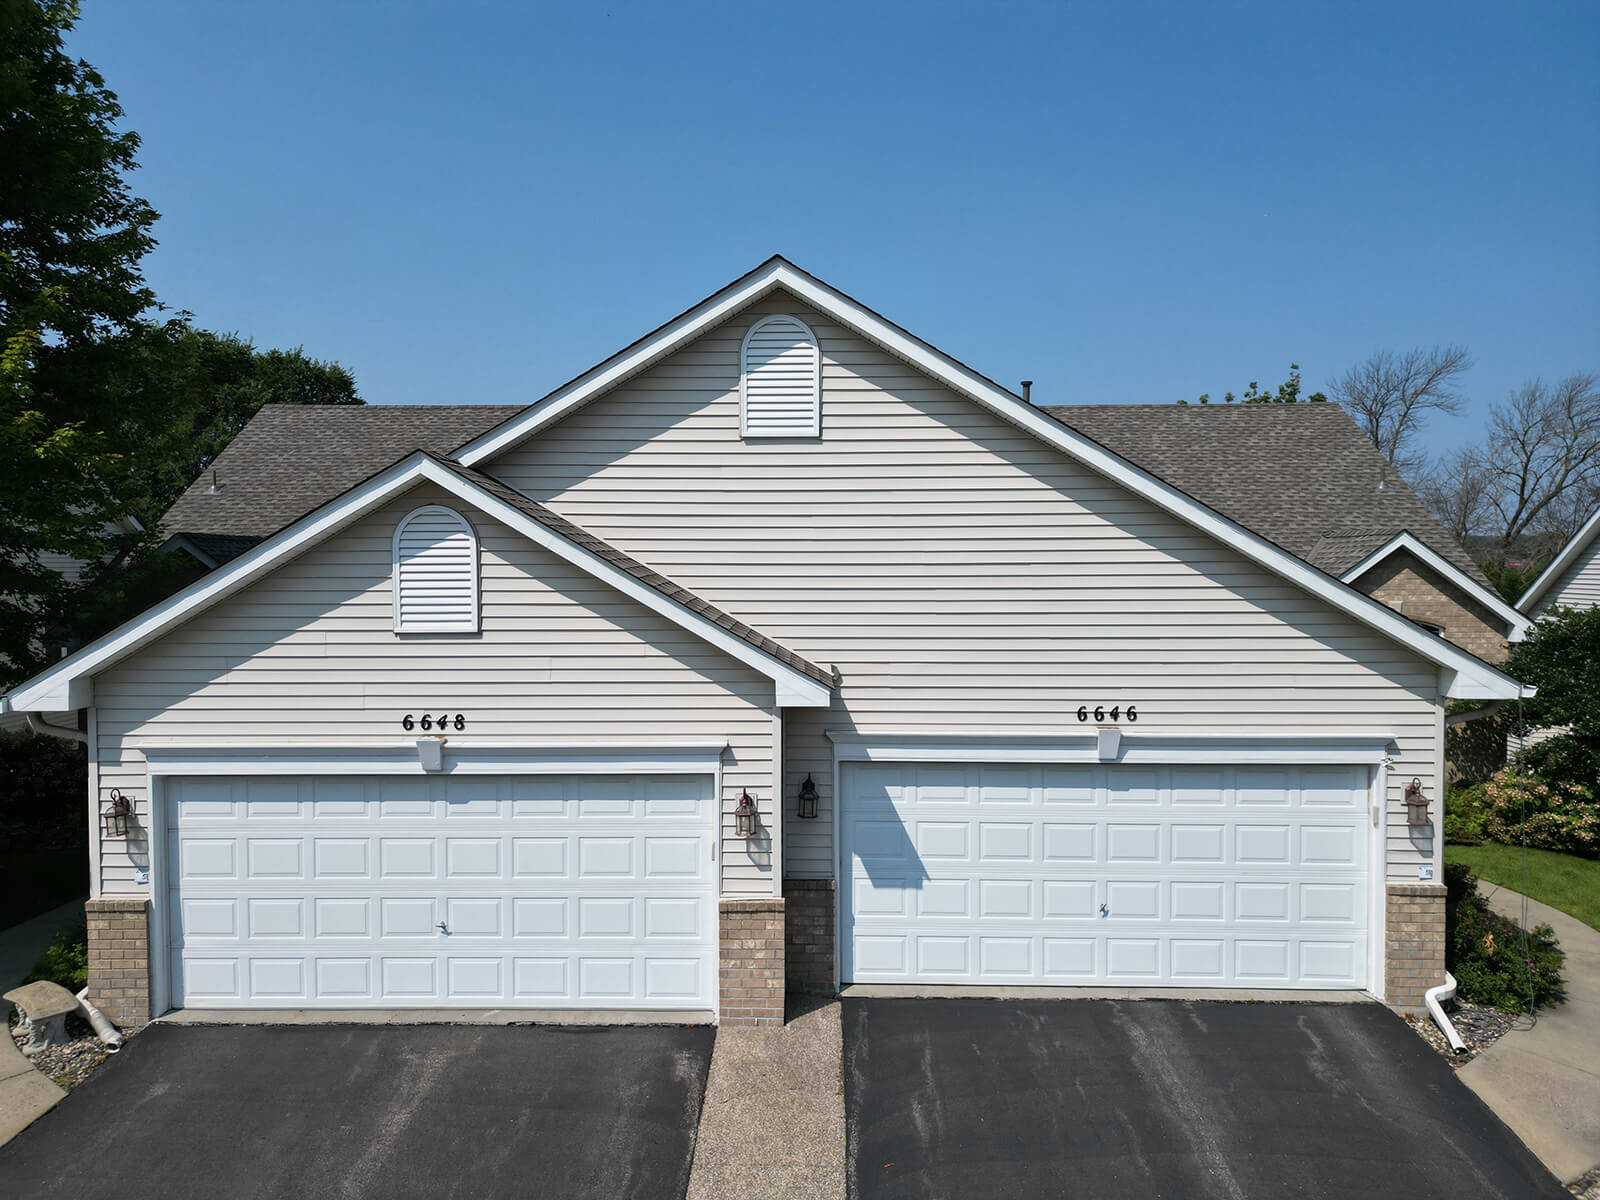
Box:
[0,450,834,712]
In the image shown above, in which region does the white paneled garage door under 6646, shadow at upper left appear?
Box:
[840,763,1370,987]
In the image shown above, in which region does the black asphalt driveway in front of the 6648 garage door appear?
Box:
[0,1024,715,1200]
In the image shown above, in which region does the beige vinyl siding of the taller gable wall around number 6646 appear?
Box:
[485,298,1443,880]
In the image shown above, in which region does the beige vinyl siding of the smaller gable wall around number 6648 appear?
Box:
[94,485,774,896]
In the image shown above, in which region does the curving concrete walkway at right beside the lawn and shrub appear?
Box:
[1456,880,1600,1182]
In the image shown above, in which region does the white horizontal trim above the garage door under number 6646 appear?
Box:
[827,726,1394,766]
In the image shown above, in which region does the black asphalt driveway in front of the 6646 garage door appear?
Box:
[843,998,1566,1200]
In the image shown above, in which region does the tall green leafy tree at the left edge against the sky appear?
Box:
[0,0,157,678]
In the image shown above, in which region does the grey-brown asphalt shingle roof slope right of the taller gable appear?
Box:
[1043,402,1490,587]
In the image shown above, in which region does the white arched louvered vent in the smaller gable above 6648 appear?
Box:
[394,504,478,634]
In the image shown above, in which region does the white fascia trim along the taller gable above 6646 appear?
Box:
[456,259,1518,699]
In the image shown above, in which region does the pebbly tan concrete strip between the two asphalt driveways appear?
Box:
[688,997,845,1200]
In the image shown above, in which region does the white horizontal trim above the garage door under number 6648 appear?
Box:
[134,739,728,776]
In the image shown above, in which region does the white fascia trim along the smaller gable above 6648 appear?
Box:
[10,453,832,712]
